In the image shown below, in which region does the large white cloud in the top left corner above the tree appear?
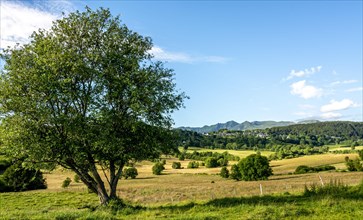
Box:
[0,0,73,49]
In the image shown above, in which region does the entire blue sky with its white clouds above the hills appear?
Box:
[0,0,363,127]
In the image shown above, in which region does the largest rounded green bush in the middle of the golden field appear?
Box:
[238,154,272,181]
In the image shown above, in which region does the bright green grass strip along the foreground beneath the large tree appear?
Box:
[0,186,363,219]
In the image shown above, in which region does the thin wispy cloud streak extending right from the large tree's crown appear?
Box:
[149,46,227,63]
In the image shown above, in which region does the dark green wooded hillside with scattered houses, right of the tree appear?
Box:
[176,121,363,159]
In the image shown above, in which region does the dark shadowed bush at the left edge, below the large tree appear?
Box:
[2,162,47,192]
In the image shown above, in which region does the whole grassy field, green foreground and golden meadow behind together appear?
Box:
[0,150,363,219]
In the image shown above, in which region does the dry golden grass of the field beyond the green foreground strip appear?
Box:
[45,150,363,205]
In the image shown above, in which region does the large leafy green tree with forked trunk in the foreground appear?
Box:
[0,8,186,204]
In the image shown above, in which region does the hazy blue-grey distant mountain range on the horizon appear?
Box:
[179,120,319,133]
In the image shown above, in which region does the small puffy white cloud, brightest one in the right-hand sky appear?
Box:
[290,80,323,99]
